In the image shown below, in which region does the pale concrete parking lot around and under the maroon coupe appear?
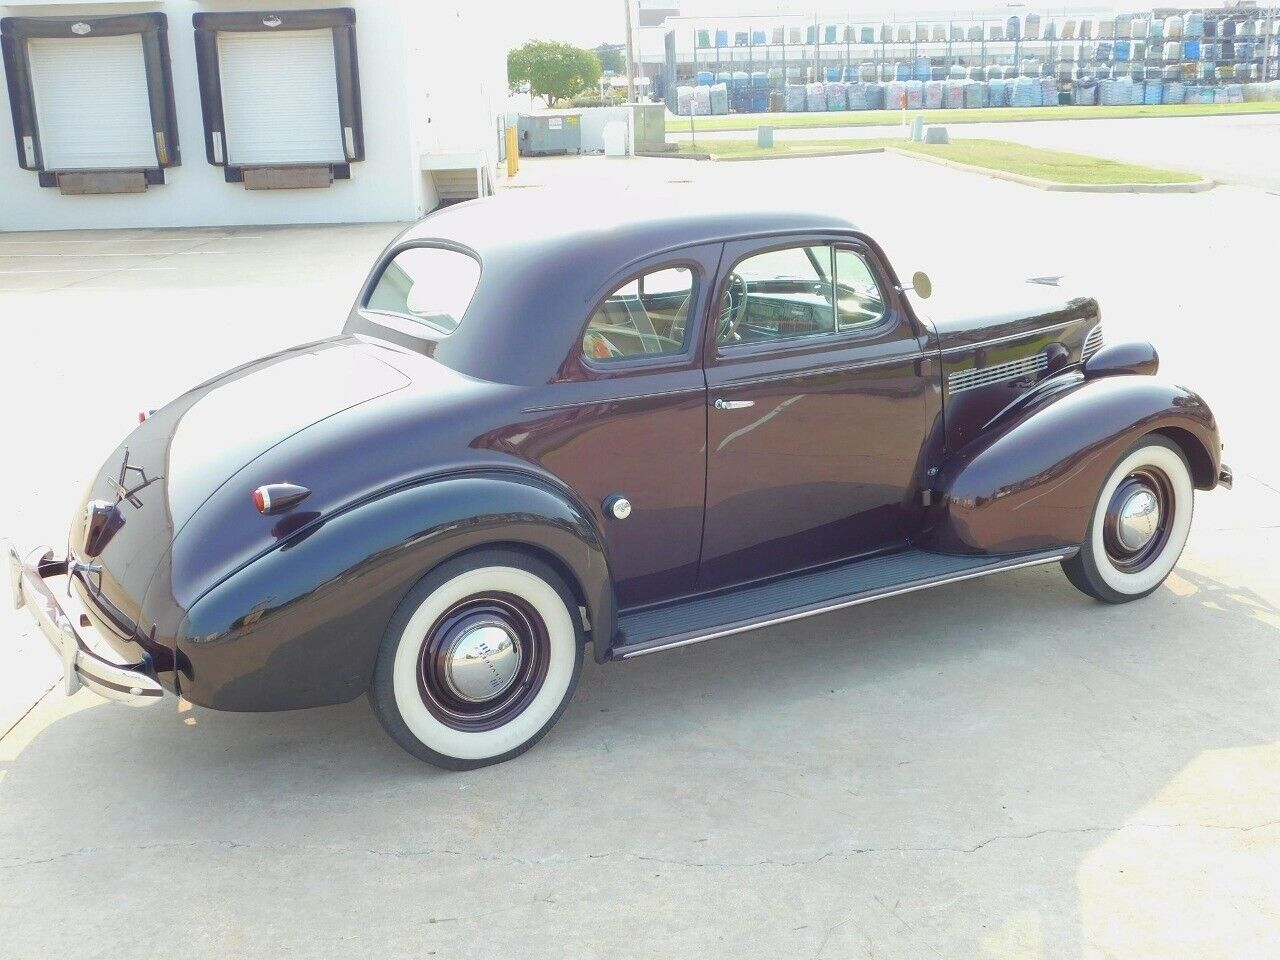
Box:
[0,146,1280,960]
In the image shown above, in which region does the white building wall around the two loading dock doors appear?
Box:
[0,0,506,230]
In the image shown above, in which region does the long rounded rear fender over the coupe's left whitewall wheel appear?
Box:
[175,471,617,710]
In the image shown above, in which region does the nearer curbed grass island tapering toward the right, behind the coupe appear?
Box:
[680,137,1199,184]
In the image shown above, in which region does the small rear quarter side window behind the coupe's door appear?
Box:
[582,266,698,364]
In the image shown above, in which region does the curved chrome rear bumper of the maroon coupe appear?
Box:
[8,547,164,707]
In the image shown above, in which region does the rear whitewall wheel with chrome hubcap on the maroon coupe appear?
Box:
[369,549,584,769]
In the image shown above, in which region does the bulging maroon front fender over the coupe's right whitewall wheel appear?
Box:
[922,375,1222,553]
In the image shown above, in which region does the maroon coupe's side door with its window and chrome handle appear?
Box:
[699,236,941,589]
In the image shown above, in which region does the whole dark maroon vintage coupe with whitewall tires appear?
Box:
[12,195,1231,768]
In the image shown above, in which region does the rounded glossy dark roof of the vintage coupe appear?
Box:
[371,192,856,383]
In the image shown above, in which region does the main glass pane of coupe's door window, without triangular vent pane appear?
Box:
[716,244,838,346]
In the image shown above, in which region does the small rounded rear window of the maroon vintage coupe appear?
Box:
[365,247,480,334]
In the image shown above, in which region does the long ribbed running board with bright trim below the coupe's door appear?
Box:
[612,547,1079,659]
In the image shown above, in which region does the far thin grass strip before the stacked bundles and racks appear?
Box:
[667,102,1280,134]
